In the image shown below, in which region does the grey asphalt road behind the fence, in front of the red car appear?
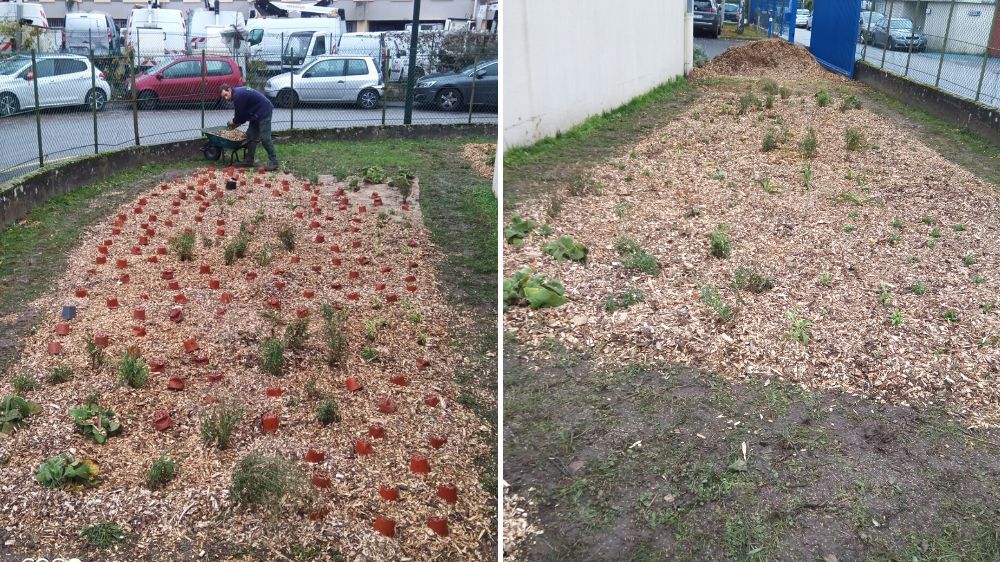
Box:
[0,100,497,182]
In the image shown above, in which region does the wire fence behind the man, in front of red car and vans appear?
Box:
[0,28,499,182]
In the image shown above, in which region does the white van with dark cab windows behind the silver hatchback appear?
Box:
[247,17,347,71]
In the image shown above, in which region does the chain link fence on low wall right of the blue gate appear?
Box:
[856,0,1000,108]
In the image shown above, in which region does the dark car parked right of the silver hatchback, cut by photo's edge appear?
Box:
[413,60,499,111]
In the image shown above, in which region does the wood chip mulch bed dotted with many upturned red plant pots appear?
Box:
[0,165,495,560]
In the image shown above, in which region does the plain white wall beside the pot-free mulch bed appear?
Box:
[501,0,687,149]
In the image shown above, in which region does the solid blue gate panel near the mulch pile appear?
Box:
[809,0,861,78]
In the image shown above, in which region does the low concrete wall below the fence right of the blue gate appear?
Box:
[854,62,1000,144]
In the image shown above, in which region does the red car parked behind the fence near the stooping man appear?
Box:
[132,56,243,109]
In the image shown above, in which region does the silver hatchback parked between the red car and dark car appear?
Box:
[264,55,385,109]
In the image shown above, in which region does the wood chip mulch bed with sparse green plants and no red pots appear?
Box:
[504,71,1000,427]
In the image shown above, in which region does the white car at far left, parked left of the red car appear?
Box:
[0,55,111,116]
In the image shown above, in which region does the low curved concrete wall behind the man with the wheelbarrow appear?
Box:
[0,124,497,228]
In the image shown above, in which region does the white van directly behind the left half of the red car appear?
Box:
[125,8,187,68]
